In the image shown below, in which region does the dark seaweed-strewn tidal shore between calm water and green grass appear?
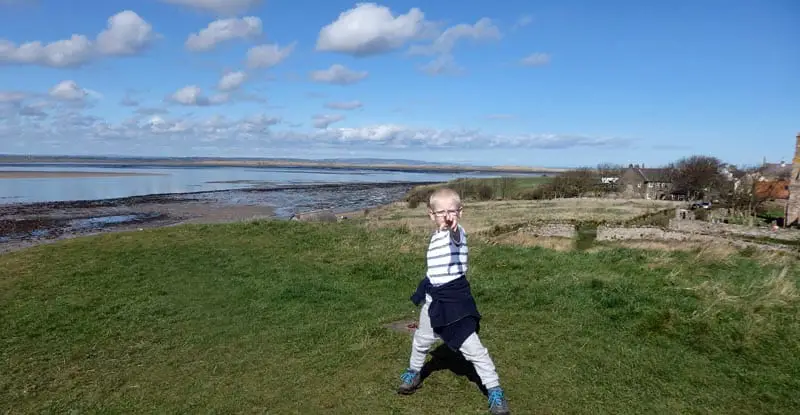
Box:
[0,182,431,254]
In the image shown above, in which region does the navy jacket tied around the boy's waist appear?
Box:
[411,277,481,351]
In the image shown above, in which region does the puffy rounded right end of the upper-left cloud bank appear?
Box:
[97,10,156,55]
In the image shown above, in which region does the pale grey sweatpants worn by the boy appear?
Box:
[409,294,500,389]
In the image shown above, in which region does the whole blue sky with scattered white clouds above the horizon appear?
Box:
[0,0,800,167]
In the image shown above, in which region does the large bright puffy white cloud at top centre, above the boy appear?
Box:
[316,3,431,56]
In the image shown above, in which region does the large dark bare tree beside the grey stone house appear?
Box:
[671,155,726,200]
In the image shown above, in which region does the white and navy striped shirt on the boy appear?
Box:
[427,225,469,287]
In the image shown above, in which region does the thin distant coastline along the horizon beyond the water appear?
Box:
[0,155,567,174]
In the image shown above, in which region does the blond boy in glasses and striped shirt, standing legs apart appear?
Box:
[398,188,509,414]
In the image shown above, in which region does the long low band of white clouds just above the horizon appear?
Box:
[0,106,630,155]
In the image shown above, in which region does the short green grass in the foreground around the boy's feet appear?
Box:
[0,222,800,414]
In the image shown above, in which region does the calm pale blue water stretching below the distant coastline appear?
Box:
[0,164,524,204]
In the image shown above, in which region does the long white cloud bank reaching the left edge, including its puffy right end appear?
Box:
[0,10,159,68]
